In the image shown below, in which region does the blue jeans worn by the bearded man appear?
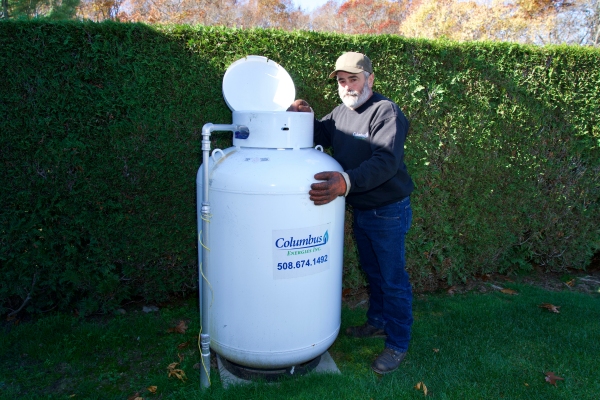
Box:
[354,197,413,352]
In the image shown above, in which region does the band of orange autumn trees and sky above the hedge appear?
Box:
[2,0,600,46]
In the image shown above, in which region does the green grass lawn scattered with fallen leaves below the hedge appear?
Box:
[0,283,600,400]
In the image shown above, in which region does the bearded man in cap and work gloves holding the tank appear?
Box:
[288,52,414,374]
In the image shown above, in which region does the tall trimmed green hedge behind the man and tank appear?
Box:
[0,21,600,314]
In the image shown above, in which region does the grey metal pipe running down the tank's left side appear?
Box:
[197,123,248,389]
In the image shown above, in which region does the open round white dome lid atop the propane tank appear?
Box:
[223,56,296,111]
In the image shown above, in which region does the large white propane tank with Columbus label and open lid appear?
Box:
[196,56,345,369]
